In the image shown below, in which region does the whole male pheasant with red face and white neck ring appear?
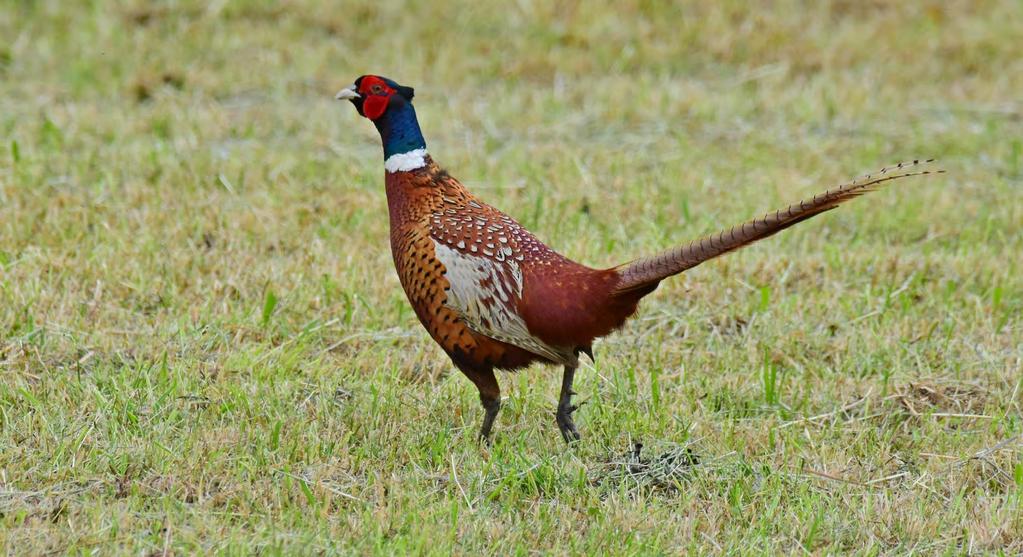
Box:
[336,75,940,442]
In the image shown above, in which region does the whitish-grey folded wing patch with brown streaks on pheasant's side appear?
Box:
[434,240,578,363]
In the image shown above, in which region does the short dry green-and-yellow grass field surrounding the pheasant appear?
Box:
[0,0,1023,555]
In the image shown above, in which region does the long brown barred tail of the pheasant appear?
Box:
[614,159,944,294]
